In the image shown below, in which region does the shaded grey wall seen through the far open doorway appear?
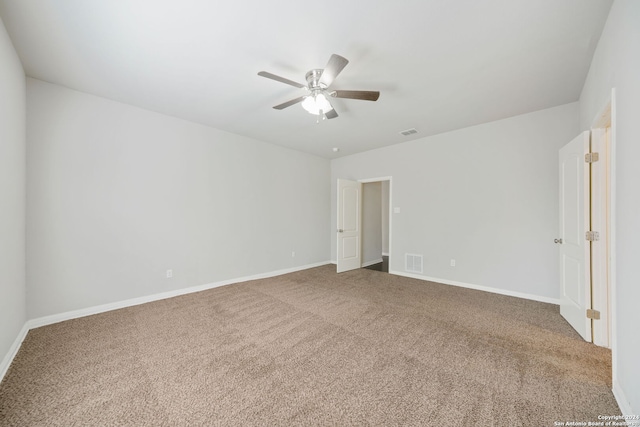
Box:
[362,182,382,266]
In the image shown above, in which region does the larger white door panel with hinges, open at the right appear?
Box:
[557,131,591,341]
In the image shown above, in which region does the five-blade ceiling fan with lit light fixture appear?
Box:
[258,54,380,120]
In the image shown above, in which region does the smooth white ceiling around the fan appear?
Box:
[0,0,611,158]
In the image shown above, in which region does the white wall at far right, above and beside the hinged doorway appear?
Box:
[580,0,640,414]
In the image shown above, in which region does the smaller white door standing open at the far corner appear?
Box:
[336,179,362,273]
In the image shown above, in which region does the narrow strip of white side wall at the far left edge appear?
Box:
[0,16,26,370]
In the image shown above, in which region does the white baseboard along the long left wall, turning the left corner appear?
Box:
[0,261,330,381]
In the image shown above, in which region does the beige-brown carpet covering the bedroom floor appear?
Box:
[0,266,620,426]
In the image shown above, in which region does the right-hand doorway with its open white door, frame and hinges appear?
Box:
[555,92,615,351]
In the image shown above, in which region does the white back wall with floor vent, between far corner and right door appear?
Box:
[331,103,578,300]
